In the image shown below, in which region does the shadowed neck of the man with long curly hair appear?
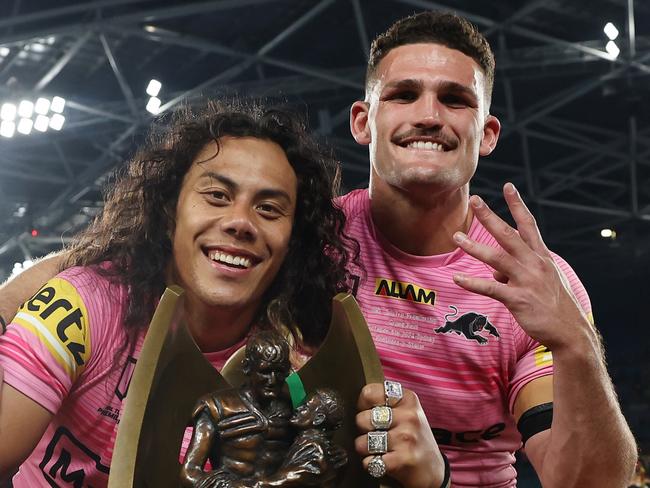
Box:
[185,295,255,352]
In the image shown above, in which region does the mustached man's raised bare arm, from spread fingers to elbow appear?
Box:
[454,185,636,488]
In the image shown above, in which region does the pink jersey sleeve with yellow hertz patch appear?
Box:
[0,277,91,414]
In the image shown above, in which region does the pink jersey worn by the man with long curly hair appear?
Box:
[0,268,243,488]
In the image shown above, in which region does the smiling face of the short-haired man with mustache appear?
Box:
[351,43,500,196]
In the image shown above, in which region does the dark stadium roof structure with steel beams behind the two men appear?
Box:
[0,0,650,278]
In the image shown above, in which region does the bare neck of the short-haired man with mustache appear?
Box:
[370,174,472,256]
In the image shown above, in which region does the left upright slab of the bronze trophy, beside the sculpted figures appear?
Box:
[108,286,230,488]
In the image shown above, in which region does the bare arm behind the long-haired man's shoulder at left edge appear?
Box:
[0,253,65,324]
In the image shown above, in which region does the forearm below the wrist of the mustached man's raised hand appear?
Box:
[538,325,636,488]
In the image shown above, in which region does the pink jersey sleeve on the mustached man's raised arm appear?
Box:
[508,254,594,413]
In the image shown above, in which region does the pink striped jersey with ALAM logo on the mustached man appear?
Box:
[338,190,591,488]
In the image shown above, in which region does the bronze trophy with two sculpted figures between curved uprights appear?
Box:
[108,286,394,488]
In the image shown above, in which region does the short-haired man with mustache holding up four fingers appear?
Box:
[346,8,636,488]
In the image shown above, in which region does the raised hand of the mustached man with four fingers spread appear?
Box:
[454,183,591,349]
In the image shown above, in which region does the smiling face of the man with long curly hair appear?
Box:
[173,136,297,317]
